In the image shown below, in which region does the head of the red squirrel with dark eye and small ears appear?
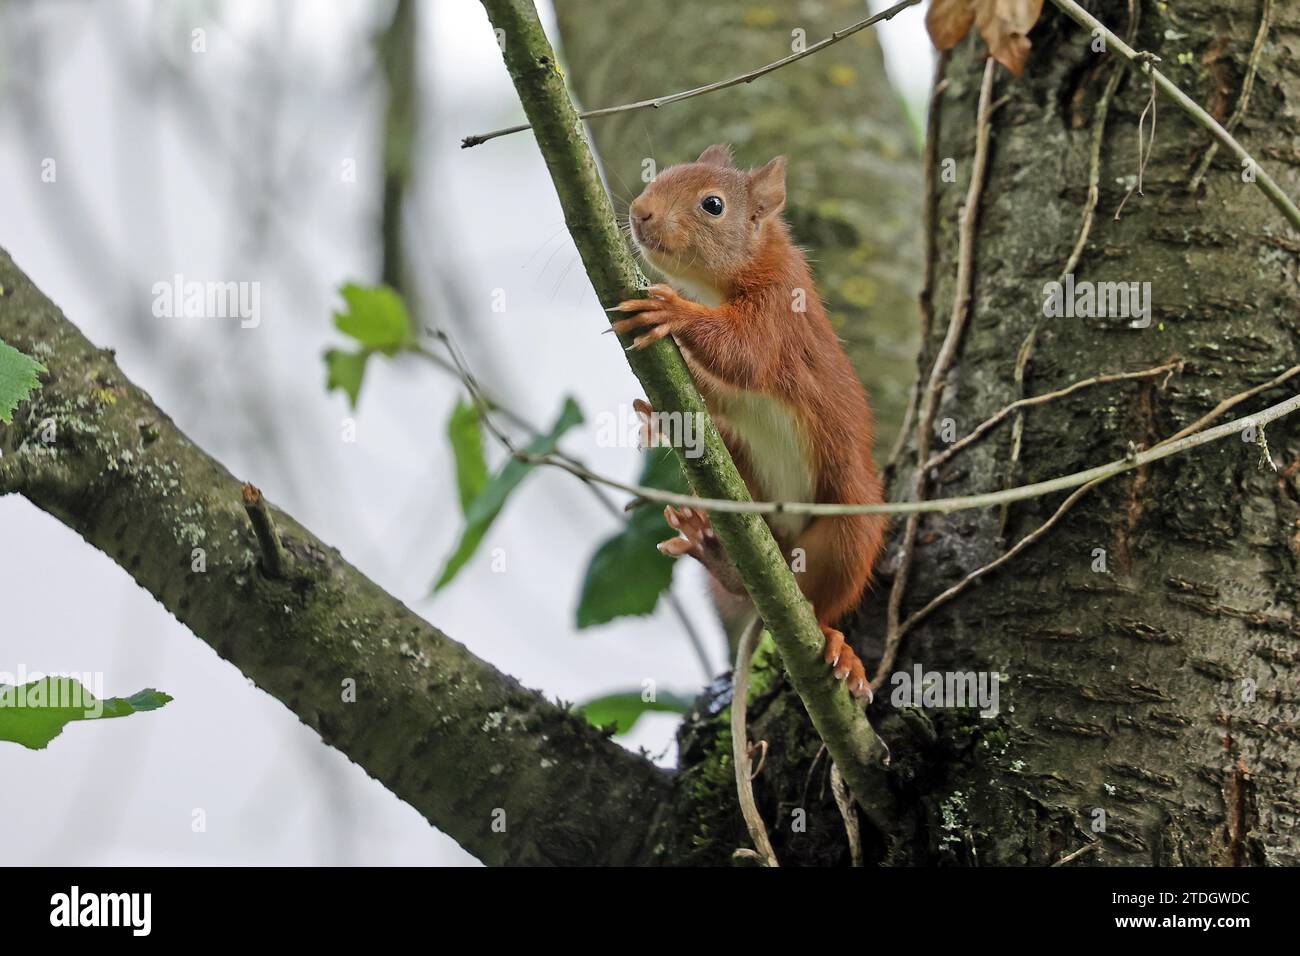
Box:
[628,146,785,287]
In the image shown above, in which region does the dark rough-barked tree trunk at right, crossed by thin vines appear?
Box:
[900,0,1300,865]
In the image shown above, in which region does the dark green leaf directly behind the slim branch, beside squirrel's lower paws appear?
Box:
[577,447,686,628]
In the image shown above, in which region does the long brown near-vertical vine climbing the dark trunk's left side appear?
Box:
[872,59,997,689]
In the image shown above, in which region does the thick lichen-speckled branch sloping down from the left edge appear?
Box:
[0,250,672,865]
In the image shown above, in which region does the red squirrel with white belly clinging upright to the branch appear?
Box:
[612,146,887,697]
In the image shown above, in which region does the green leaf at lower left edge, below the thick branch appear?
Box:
[0,678,172,750]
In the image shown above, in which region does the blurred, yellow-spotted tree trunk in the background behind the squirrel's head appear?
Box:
[555,0,922,457]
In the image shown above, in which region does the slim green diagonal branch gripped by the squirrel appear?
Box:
[484,0,893,836]
